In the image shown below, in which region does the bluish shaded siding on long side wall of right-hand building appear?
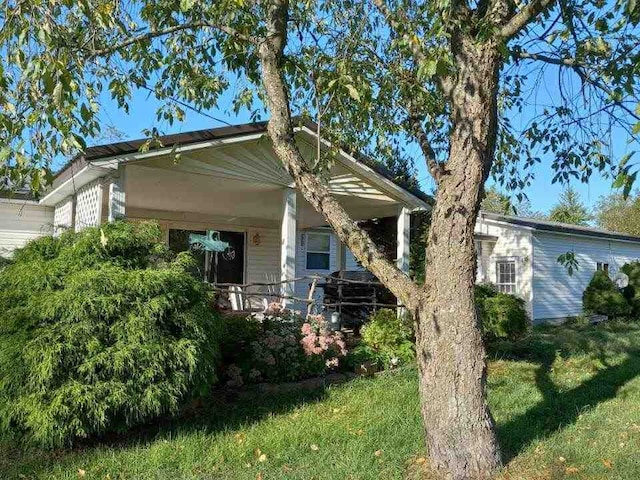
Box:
[533,231,640,321]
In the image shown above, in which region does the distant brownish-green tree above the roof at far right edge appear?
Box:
[595,190,640,236]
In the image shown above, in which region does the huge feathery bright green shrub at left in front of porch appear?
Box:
[0,222,217,446]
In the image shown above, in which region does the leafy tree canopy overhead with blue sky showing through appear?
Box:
[0,0,640,198]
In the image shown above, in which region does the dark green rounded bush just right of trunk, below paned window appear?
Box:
[475,284,530,341]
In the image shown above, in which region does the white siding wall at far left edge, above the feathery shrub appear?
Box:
[0,198,53,257]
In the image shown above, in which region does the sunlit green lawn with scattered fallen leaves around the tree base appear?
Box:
[0,324,640,480]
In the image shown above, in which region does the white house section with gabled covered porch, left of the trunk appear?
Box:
[0,123,429,308]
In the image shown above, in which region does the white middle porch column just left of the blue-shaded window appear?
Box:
[280,187,298,306]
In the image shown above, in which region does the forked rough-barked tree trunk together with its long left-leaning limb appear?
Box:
[258,0,501,480]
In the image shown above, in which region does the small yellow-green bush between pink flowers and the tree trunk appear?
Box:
[353,309,416,368]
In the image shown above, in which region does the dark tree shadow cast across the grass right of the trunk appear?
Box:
[493,336,640,462]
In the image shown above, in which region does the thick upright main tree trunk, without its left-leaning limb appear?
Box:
[417,38,508,479]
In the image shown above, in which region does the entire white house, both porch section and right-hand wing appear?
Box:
[5,119,640,322]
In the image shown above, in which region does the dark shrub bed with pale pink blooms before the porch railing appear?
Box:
[221,304,346,387]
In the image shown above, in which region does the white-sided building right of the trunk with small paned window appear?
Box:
[475,212,640,323]
